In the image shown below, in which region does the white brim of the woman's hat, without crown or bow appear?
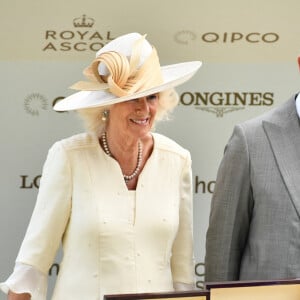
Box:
[53,61,202,111]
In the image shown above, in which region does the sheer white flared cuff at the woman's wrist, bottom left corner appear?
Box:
[0,263,47,300]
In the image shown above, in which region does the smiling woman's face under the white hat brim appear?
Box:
[108,93,159,138]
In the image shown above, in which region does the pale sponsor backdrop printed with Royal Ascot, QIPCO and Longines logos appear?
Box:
[0,0,300,300]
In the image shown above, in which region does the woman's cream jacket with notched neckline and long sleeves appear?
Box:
[17,134,194,300]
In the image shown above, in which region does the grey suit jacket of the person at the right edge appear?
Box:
[205,97,300,281]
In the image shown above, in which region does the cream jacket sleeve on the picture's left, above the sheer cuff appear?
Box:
[16,142,72,274]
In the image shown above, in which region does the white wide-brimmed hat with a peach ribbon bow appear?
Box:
[54,33,202,111]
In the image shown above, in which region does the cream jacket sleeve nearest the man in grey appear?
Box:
[171,153,195,286]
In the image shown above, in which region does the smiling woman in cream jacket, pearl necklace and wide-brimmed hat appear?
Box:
[1,33,201,300]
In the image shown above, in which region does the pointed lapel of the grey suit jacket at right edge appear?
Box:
[263,99,300,218]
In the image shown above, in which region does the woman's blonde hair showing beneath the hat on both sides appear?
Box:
[77,89,179,136]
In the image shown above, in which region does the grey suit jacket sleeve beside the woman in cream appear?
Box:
[205,125,253,282]
